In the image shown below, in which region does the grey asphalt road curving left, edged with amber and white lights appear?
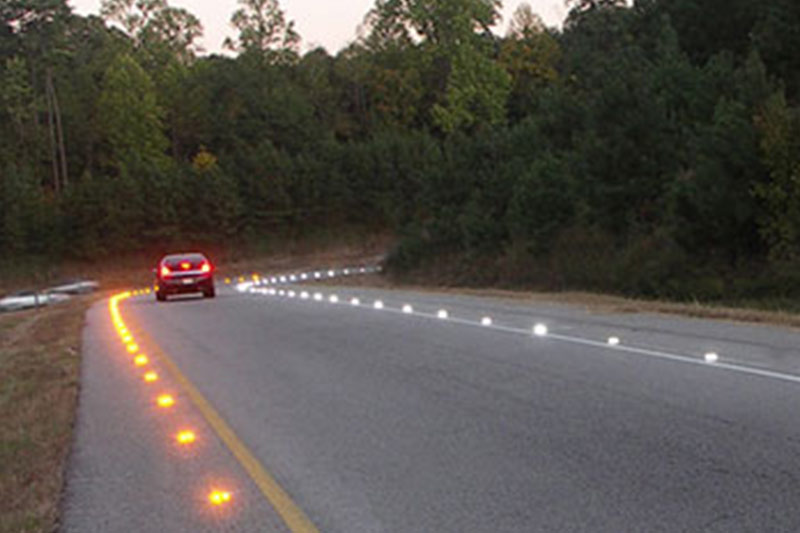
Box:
[62,276,800,533]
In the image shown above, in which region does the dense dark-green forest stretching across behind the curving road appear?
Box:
[0,0,800,300]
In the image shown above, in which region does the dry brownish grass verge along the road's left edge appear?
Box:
[0,297,93,533]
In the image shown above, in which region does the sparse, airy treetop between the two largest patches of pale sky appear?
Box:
[225,0,300,64]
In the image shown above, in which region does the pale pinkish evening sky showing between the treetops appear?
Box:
[68,0,567,54]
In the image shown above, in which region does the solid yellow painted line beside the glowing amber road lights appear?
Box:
[119,300,319,533]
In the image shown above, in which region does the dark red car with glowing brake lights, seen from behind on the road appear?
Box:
[155,253,216,302]
